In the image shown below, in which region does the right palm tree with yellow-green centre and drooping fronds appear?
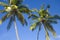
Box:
[29,5,60,40]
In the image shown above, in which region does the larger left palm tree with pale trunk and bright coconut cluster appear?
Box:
[0,0,31,40]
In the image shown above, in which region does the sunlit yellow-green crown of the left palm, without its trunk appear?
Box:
[0,0,31,28]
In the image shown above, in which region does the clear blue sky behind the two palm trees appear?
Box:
[0,0,60,40]
